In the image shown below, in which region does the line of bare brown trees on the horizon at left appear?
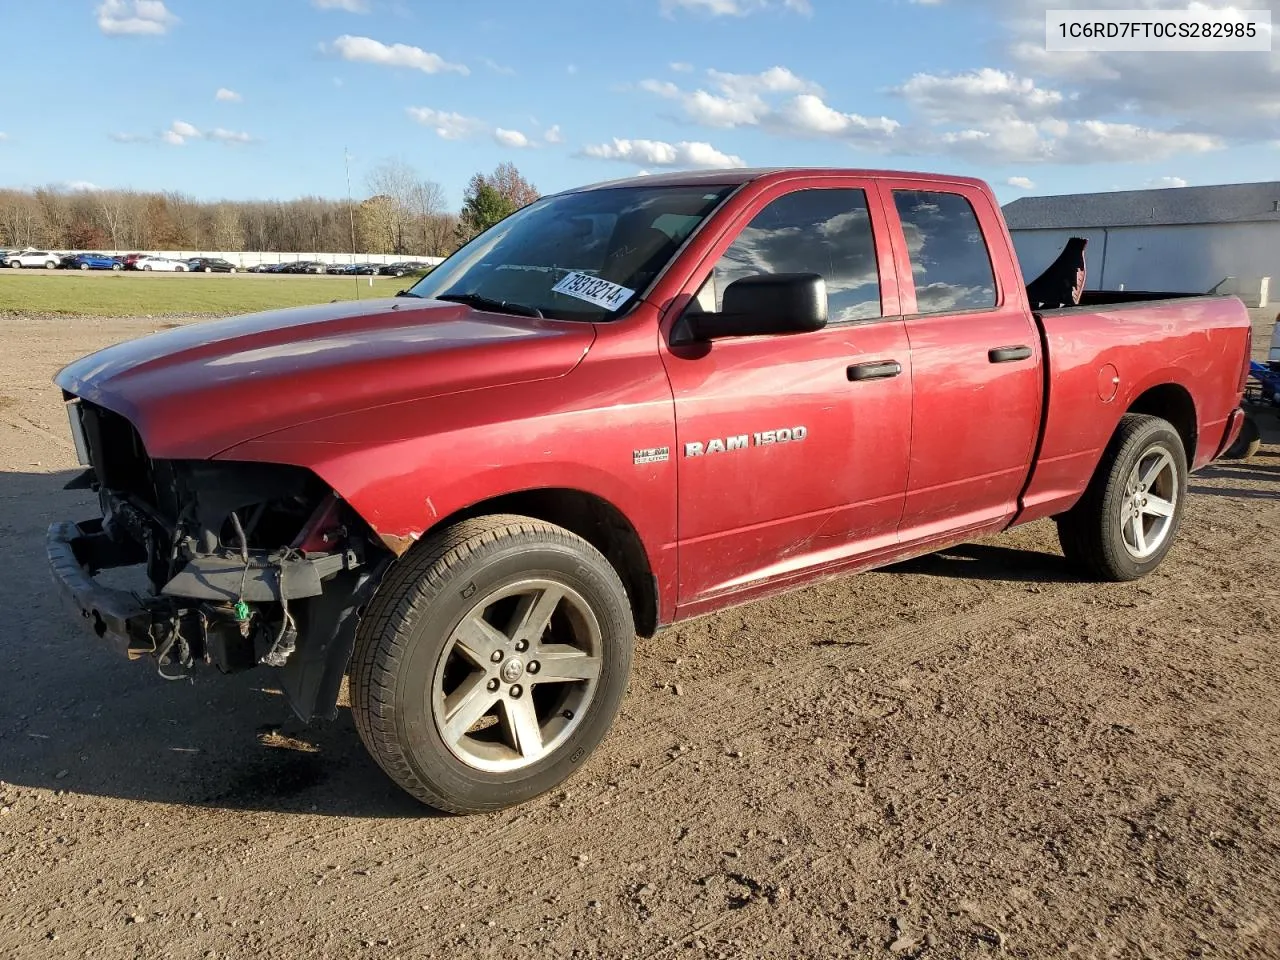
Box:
[0,161,539,257]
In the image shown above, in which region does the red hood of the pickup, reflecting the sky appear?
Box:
[54,298,595,460]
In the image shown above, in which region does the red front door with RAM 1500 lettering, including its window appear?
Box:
[663,178,911,616]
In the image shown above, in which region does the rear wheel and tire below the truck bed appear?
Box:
[1056,413,1187,582]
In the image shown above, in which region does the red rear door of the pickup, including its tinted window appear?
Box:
[881,180,1043,544]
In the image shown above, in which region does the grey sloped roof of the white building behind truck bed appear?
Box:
[1004,180,1280,230]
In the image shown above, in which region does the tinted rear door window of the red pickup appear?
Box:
[893,189,996,314]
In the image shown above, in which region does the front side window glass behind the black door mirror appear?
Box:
[699,189,881,324]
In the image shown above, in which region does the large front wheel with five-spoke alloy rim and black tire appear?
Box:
[351,516,635,814]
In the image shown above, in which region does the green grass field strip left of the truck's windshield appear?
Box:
[0,270,416,316]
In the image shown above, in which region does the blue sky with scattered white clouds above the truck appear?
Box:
[0,0,1280,206]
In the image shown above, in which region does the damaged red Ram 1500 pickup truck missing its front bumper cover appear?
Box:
[47,169,1249,812]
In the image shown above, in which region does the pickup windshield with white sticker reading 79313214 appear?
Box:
[408,186,733,321]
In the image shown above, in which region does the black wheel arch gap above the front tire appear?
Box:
[422,486,658,637]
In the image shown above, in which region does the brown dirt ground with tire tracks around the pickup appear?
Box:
[0,314,1280,959]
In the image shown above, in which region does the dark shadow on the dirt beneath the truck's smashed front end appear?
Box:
[0,471,433,818]
